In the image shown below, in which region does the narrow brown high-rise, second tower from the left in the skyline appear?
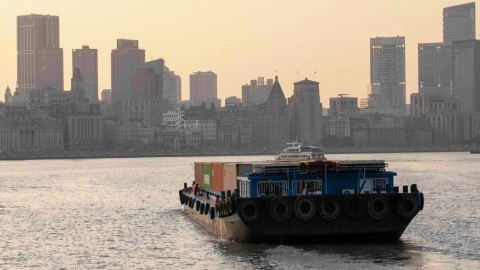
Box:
[72,46,98,101]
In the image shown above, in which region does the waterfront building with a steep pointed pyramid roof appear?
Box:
[248,76,290,151]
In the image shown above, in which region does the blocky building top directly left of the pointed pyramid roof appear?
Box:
[242,77,273,106]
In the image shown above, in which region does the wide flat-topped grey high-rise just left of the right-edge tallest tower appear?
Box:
[418,42,453,96]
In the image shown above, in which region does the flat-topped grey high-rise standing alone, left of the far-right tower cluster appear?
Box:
[370,36,405,114]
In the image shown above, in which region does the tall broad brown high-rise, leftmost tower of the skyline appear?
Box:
[17,14,63,96]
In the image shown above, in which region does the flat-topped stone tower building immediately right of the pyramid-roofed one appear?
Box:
[288,78,322,145]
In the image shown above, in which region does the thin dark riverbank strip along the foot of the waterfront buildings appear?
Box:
[0,147,470,160]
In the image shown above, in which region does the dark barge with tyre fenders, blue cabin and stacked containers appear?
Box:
[179,156,424,242]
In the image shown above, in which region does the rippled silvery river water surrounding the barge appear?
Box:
[0,152,480,269]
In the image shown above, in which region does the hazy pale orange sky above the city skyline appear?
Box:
[0,0,478,107]
